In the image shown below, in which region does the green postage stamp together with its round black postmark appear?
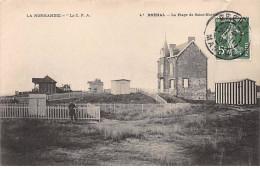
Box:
[204,11,250,60]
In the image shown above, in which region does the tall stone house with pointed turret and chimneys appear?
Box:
[157,37,208,100]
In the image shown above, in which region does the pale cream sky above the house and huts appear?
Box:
[0,0,260,95]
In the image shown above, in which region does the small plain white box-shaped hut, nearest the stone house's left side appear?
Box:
[111,79,130,95]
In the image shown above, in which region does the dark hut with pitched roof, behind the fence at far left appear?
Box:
[32,76,57,94]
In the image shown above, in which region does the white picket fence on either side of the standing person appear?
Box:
[0,104,100,121]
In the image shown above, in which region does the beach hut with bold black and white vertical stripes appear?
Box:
[215,79,257,105]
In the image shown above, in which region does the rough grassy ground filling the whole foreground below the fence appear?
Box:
[1,104,259,165]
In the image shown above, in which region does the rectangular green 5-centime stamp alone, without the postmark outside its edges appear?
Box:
[215,18,249,59]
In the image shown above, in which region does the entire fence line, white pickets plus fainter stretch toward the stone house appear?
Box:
[0,103,189,121]
